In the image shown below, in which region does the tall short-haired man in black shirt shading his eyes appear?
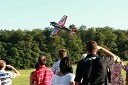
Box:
[75,41,120,85]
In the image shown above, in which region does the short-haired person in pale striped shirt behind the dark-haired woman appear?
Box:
[52,49,73,74]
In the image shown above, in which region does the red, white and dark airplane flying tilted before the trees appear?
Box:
[50,15,77,38]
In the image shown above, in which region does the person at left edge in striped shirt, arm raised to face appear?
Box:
[0,60,20,85]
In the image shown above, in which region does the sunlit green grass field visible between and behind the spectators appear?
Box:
[13,62,128,85]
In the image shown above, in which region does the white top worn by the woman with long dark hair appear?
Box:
[52,73,75,85]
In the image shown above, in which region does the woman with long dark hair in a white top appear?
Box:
[52,57,75,85]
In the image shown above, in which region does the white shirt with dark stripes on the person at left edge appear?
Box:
[0,70,16,85]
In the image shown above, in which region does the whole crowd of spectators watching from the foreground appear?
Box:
[0,41,128,85]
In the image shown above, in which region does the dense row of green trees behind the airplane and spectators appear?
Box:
[0,25,128,69]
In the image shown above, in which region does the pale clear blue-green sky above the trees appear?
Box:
[0,0,128,30]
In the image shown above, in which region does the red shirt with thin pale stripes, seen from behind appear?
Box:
[32,65,53,85]
